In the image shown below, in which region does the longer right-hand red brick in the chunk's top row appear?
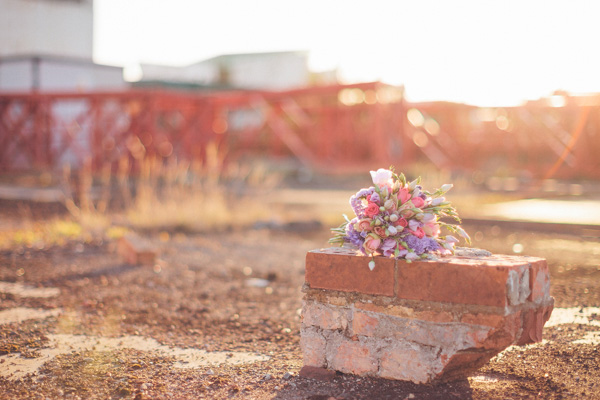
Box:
[396,259,523,307]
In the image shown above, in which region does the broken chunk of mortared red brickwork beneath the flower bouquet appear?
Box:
[301,248,554,383]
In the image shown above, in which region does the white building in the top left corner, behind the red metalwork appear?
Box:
[0,0,127,92]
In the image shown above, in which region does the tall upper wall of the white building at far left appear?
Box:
[0,0,93,60]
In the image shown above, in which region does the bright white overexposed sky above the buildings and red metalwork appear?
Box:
[94,0,600,106]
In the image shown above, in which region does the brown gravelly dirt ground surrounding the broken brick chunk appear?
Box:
[0,202,600,400]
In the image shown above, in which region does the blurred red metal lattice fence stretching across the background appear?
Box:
[0,83,600,178]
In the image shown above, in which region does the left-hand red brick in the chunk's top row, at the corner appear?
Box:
[305,248,395,296]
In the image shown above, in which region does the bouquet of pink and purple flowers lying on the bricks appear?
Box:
[329,168,470,270]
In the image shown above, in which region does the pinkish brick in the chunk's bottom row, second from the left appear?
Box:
[327,339,378,376]
